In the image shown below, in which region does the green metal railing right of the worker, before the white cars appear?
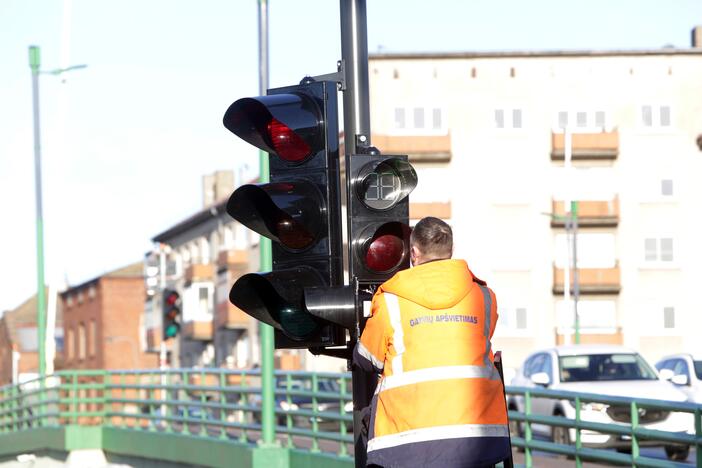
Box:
[506,386,702,467]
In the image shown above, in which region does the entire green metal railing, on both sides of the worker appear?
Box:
[0,368,702,467]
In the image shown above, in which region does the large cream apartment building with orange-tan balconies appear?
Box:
[369,28,702,367]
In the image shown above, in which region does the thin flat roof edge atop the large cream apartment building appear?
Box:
[368,47,702,60]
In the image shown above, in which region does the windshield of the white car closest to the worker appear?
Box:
[559,353,657,382]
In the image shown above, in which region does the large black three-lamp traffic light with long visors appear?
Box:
[224,78,346,348]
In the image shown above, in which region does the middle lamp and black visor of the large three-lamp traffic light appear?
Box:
[227,181,326,251]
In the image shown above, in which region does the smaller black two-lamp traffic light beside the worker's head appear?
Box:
[346,155,417,289]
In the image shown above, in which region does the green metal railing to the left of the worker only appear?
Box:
[0,368,353,466]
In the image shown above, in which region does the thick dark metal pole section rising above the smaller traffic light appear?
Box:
[340,0,371,155]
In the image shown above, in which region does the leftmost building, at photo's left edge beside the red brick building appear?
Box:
[0,288,63,386]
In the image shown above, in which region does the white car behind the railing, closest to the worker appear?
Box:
[508,345,694,460]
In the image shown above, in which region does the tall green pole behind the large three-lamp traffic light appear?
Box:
[258,0,275,445]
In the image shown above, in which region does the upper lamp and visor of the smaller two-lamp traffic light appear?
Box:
[354,158,417,211]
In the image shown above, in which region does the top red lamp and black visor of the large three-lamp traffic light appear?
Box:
[223,93,324,163]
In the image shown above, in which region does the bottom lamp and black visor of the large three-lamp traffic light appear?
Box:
[229,267,324,341]
